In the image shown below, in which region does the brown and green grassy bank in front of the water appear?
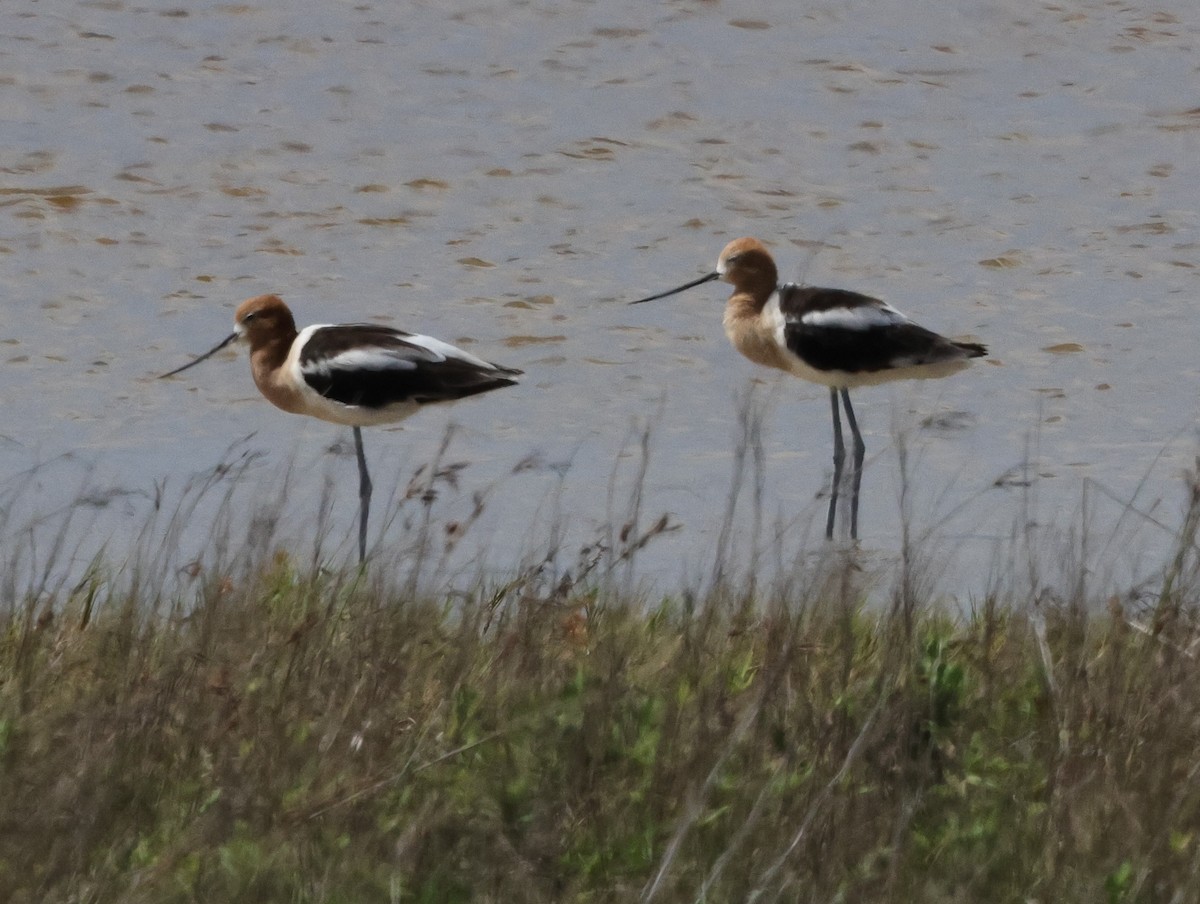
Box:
[0,511,1200,904]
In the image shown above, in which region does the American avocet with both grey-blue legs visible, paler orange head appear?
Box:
[630,238,988,539]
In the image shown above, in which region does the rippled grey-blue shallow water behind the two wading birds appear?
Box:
[0,0,1200,597]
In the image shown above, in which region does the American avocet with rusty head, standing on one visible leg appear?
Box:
[162,295,521,562]
